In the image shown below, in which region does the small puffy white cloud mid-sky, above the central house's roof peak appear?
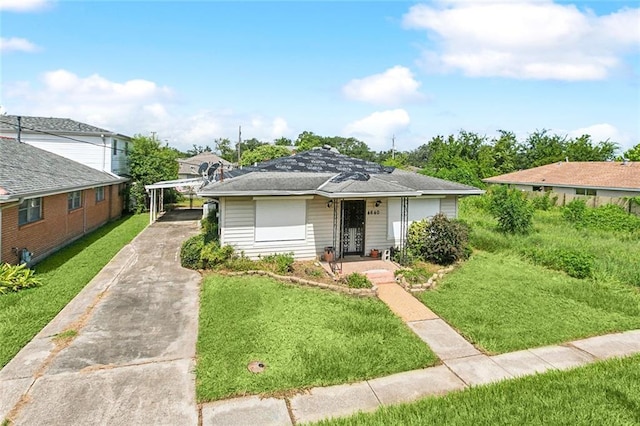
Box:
[342,65,423,105]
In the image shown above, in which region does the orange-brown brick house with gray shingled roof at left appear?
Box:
[0,137,127,264]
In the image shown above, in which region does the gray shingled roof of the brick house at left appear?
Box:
[0,138,126,200]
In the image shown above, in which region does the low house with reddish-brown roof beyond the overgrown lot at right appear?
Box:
[483,161,640,197]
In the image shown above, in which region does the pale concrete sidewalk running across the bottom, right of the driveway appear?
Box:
[202,330,640,425]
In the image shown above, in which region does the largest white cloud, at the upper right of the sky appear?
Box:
[403,0,640,81]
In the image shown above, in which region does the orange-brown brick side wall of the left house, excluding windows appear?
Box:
[0,185,122,263]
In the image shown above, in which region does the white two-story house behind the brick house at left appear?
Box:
[0,115,132,176]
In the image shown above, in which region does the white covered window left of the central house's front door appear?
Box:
[255,199,307,242]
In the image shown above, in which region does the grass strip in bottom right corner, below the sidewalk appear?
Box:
[321,356,640,426]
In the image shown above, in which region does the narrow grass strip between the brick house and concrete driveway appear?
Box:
[0,214,149,366]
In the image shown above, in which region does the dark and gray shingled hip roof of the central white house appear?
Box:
[198,149,483,198]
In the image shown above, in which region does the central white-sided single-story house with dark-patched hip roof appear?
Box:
[197,147,483,259]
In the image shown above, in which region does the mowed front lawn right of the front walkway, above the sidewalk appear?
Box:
[421,252,640,353]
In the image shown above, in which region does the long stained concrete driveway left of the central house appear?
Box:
[0,210,201,425]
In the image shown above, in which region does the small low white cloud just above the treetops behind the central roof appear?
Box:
[344,108,411,151]
